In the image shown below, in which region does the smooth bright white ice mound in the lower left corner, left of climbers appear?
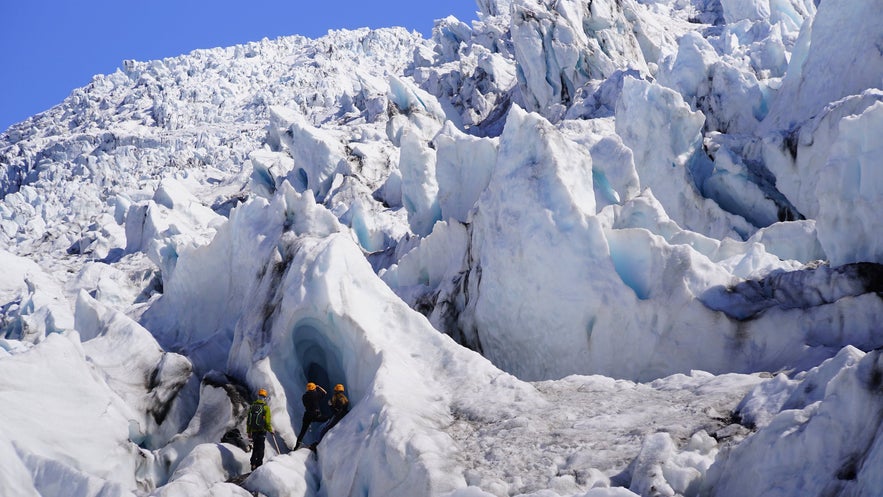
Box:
[0,332,151,497]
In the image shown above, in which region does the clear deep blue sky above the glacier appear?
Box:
[0,0,477,132]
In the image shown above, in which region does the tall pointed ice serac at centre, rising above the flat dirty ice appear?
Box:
[461,103,612,378]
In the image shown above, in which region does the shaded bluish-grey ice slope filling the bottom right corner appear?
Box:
[703,349,883,497]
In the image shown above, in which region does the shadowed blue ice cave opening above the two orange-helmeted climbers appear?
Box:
[291,321,346,414]
